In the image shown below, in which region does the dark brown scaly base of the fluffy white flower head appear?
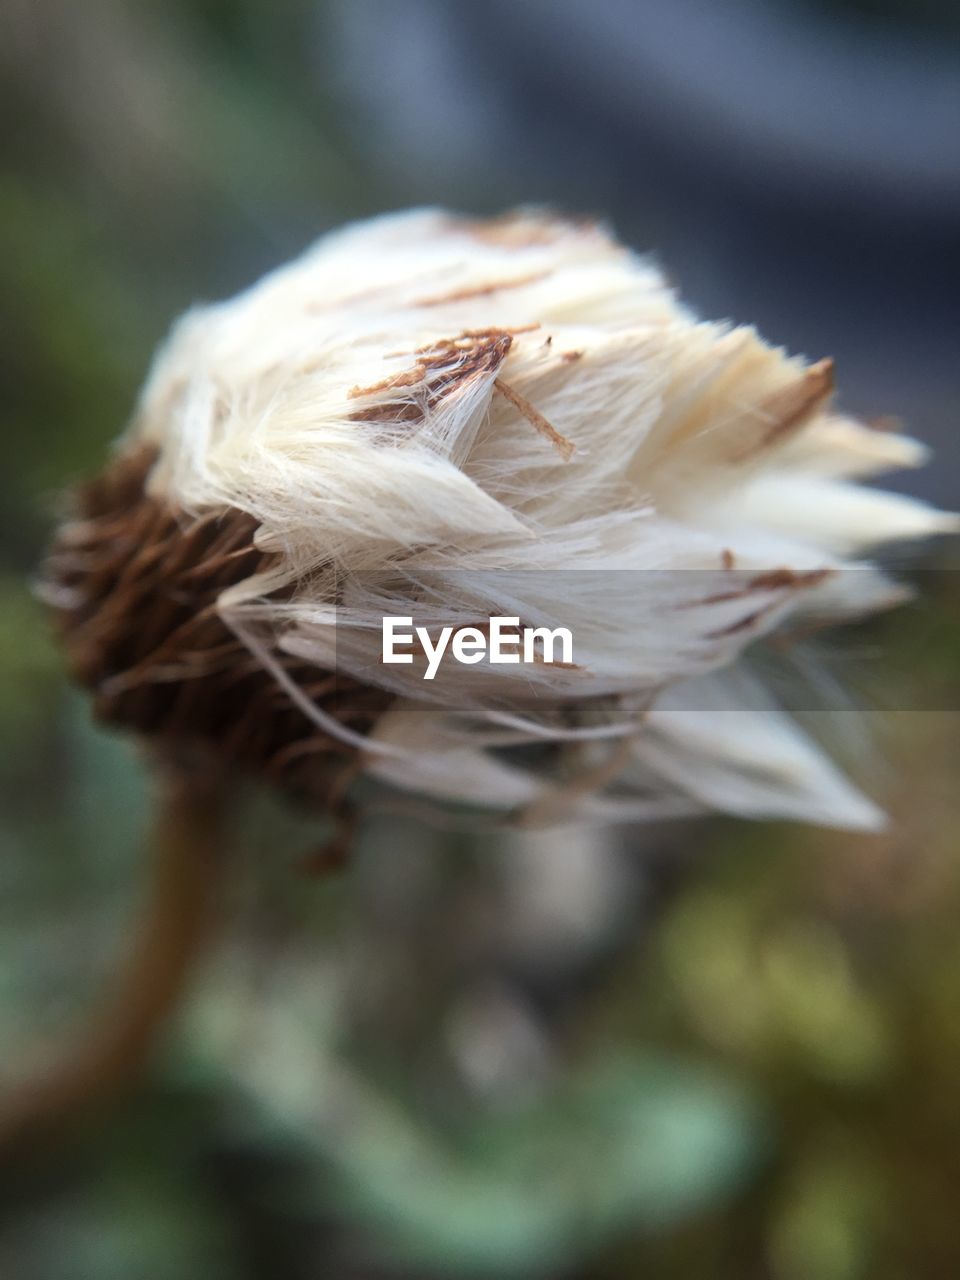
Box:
[45,447,392,804]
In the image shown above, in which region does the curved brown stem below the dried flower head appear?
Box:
[0,765,227,1155]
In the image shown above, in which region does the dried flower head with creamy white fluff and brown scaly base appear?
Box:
[49,211,956,828]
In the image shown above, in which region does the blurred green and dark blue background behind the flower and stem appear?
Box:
[0,0,960,1280]
